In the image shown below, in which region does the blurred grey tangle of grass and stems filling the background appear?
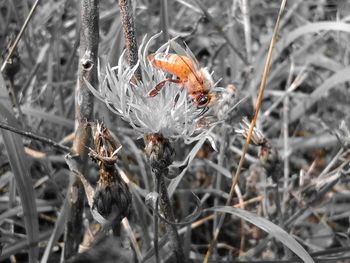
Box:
[0,0,350,262]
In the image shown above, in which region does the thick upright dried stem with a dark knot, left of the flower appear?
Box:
[64,0,99,259]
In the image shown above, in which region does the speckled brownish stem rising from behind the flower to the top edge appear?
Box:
[119,0,141,80]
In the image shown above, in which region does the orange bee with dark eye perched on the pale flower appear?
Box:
[147,53,215,108]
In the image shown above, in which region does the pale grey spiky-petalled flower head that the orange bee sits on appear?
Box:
[87,34,215,143]
